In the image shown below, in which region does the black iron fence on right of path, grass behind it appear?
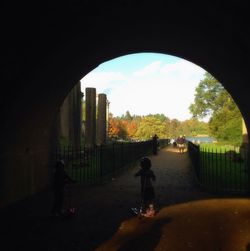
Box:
[188,142,250,193]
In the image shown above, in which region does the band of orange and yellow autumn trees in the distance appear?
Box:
[108,111,208,140]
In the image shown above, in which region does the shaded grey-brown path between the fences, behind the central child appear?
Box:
[97,147,213,210]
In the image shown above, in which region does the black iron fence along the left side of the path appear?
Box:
[55,139,169,185]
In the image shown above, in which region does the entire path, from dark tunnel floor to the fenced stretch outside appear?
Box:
[0,147,250,251]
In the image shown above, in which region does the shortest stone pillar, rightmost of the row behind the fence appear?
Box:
[97,93,107,145]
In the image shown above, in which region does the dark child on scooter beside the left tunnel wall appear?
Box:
[52,160,74,216]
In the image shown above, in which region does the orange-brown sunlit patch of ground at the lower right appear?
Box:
[96,199,250,251]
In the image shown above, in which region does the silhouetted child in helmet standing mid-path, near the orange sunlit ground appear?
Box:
[135,157,156,214]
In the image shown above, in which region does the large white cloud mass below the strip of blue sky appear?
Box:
[81,60,205,120]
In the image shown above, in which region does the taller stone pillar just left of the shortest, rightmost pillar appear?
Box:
[85,87,96,147]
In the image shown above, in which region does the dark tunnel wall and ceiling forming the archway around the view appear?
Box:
[0,1,250,207]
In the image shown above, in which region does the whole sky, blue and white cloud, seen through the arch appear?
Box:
[81,53,205,121]
